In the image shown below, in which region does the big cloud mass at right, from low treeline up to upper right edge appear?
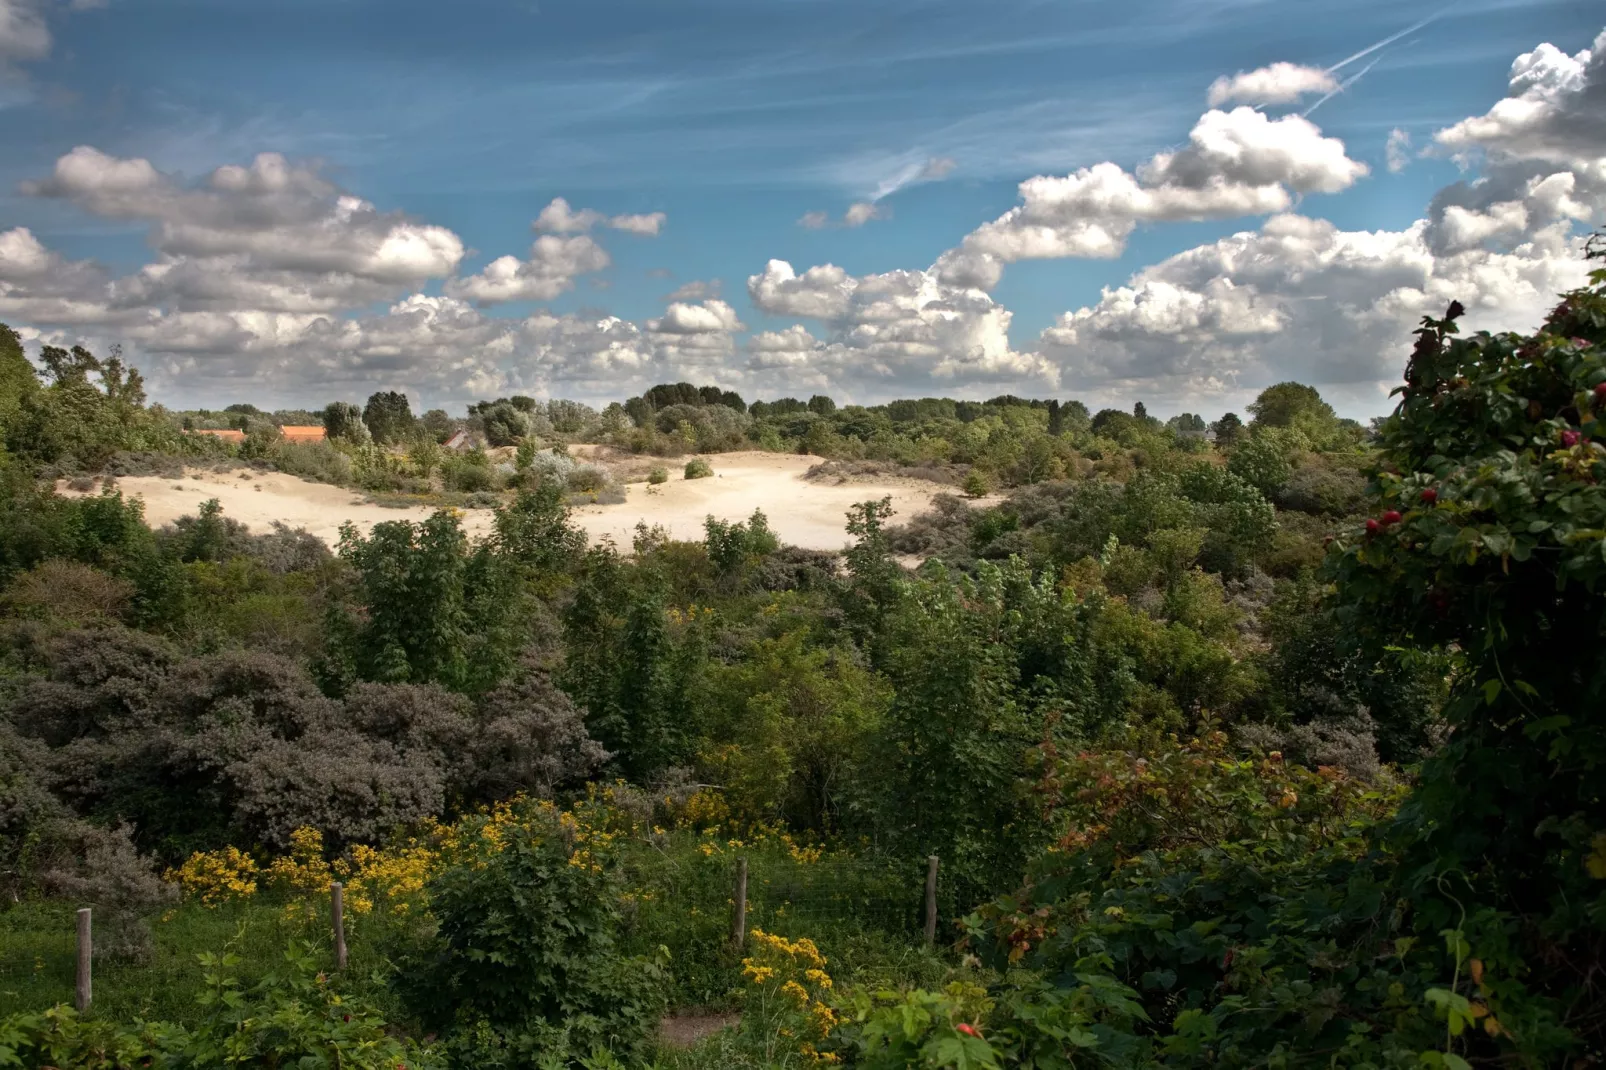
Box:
[1002,25,1606,408]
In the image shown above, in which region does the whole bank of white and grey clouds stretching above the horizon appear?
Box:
[0,0,1606,411]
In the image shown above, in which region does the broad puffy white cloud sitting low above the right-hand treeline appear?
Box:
[1041,215,1584,408]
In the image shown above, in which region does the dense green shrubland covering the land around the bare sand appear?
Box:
[0,244,1606,1070]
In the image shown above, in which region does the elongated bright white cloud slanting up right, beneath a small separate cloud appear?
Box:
[940,108,1367,289]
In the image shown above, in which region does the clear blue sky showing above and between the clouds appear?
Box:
[0,0,1606,415]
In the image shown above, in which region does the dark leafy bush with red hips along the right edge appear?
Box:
[1331,247,1606,1062]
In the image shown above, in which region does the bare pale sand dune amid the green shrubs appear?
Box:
[61,451,963,549]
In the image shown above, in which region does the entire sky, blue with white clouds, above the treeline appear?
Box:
[0,0,1606,419]
